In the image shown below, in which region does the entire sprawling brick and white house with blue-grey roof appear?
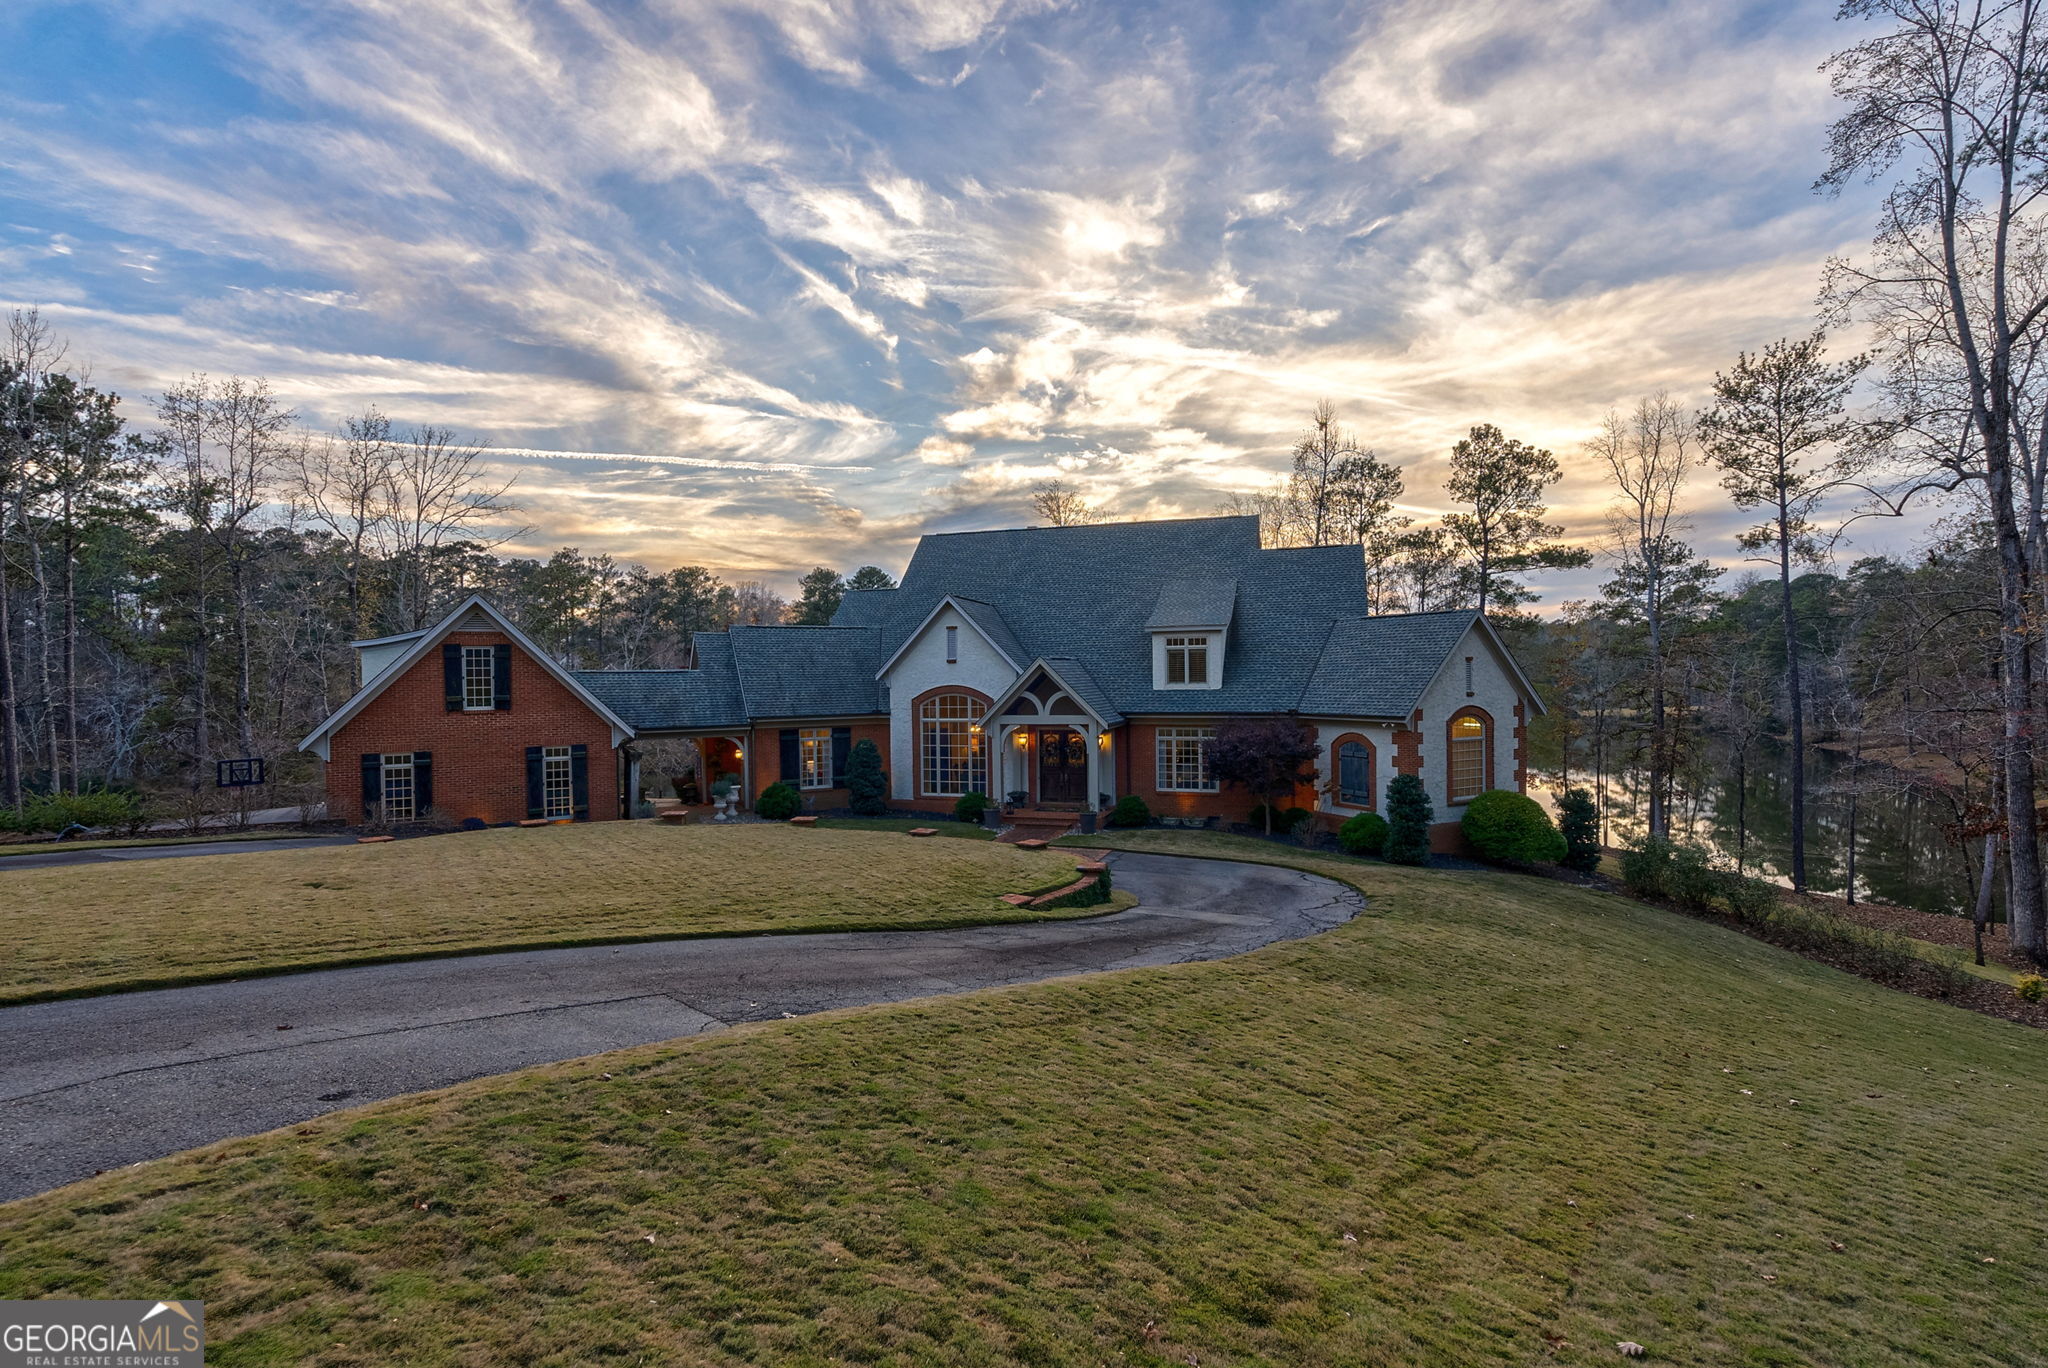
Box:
[309,516,1542,846]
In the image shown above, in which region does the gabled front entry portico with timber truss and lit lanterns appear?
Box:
[987,659,1124,809]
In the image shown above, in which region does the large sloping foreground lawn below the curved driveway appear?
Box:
[0,836,2048,1368]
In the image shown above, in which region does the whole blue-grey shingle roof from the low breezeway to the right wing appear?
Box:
[575,518,1523,731]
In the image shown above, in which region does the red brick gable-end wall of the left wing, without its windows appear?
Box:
[328,631,618,823]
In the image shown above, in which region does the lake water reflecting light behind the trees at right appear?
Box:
[1542,743,2003,920]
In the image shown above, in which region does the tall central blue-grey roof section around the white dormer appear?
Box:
[834,518,1366,715]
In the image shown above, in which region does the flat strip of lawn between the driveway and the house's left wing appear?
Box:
[0,821,1073,1003]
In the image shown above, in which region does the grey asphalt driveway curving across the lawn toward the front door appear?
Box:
[0,854,1362,1200]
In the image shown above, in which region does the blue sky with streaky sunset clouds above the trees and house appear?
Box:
[0,0,1898,602]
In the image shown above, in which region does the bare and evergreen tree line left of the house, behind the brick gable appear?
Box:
[0,311,893,817]
